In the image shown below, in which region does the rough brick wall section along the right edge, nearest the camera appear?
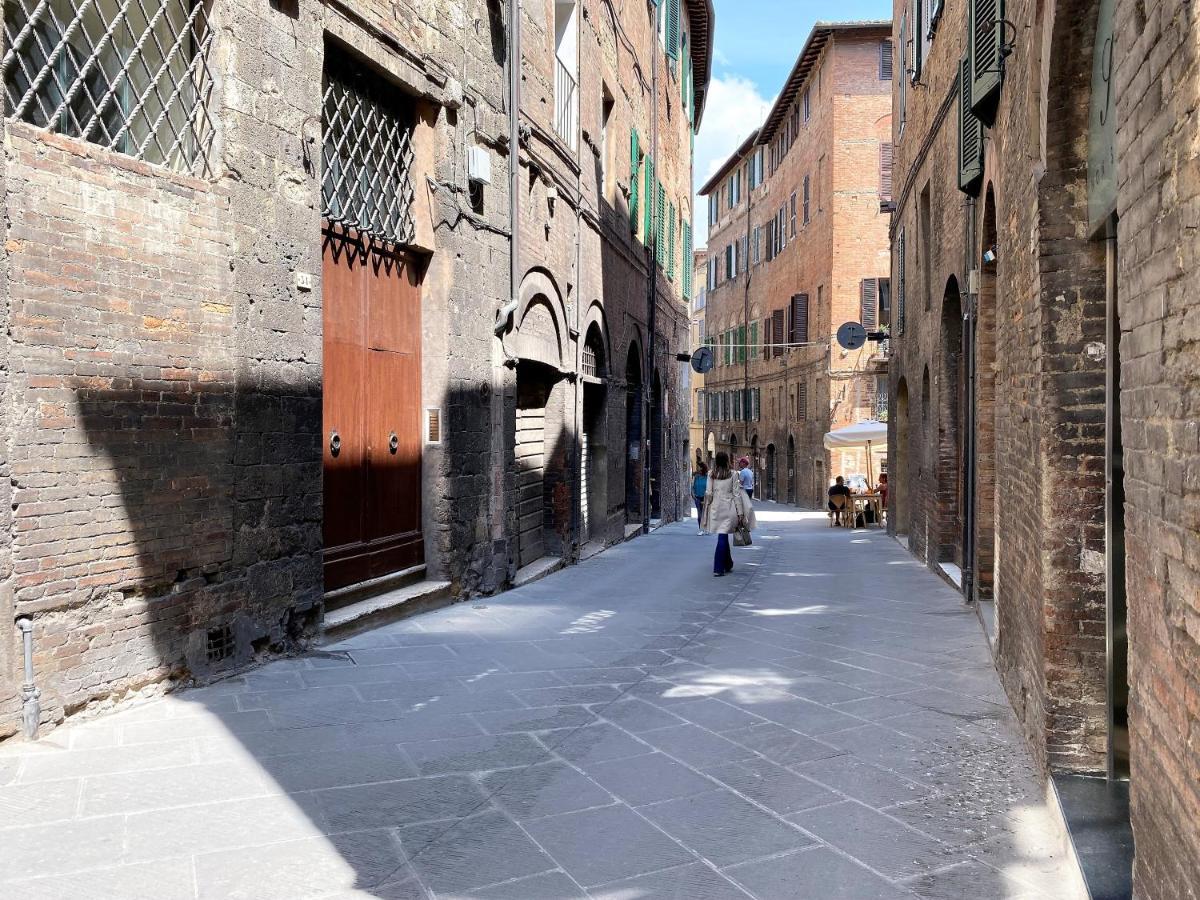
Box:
[1114,0,1200,898]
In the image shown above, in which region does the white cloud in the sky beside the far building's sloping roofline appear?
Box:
[692,76,775,247]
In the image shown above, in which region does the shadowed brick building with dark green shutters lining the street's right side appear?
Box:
[889,0,1200,900]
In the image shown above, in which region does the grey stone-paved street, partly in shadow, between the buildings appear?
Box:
[0,504,1081,900]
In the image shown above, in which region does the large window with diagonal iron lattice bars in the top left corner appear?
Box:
[0,0,214,175]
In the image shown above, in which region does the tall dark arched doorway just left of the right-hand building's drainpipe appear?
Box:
[935,276,965,566]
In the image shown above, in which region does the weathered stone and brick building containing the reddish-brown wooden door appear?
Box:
[0,0,714,738]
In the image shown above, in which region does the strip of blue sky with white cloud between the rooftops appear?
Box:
[694,0,892,247]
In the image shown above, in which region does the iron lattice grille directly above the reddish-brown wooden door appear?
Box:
[320,59,414,244]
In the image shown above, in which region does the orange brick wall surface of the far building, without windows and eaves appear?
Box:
[706,29,890,508]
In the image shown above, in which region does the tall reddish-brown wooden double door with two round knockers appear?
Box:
[323,230,425,590]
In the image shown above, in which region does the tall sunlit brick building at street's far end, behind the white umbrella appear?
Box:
[701,22,892,506]
